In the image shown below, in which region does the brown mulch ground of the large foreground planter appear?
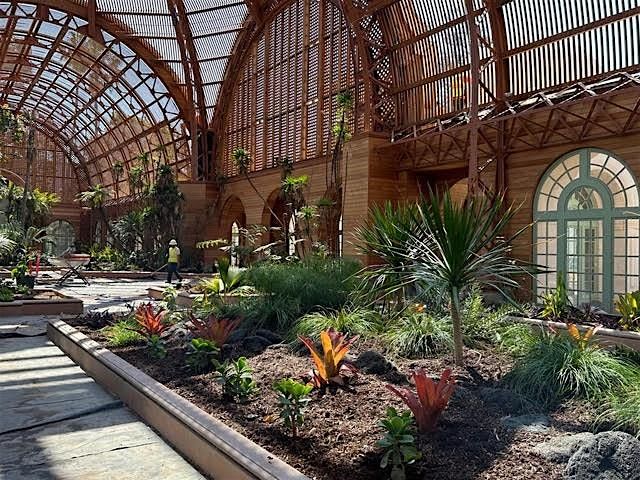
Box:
[67,321,589,480]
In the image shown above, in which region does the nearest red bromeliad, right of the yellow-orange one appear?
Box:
[387,368,456,433]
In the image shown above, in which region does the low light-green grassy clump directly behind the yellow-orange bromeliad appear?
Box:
[293,308,382,338]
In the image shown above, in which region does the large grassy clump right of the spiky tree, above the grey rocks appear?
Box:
[505,326,632,406]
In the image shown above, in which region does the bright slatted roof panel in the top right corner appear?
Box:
[503,0,640,96]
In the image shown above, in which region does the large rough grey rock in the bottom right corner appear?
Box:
[564,432,640,480]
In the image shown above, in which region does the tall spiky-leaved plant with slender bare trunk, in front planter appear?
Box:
[364,191,541,366]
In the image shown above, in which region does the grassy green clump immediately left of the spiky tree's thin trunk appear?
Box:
[384,306,453,358]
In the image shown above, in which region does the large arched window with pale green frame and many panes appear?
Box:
[534,148,640,311]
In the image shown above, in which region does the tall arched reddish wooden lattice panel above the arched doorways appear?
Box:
[222,0,363,175]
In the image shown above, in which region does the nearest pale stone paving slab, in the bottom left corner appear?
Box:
[0,408,203,480]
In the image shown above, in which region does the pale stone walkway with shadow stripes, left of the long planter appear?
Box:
[0,285,203,480]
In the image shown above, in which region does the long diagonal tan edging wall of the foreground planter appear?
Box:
[47,320,310,480]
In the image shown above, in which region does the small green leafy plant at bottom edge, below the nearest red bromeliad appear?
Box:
[377,408,422,480]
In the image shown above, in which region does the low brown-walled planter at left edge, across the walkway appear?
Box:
[0,290,84,317]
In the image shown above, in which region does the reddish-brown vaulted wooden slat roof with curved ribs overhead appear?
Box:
[0,0,640,195]
